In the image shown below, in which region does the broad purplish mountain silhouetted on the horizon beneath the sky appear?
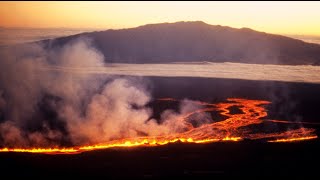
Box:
[43,21,320,65]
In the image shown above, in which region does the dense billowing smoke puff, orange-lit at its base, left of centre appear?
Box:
[61,79,151,143]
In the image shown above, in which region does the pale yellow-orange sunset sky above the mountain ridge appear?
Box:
[0,1,320,35]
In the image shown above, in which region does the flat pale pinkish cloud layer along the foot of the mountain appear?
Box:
[40,62,320,84]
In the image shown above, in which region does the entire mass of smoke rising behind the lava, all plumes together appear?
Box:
[0,39,208,147]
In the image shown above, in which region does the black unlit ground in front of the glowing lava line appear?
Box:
[0,141,320,179]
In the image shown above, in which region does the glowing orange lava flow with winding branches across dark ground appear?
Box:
[0,98,318,154]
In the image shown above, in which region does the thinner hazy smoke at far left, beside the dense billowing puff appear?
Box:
[0,39,109,146]
